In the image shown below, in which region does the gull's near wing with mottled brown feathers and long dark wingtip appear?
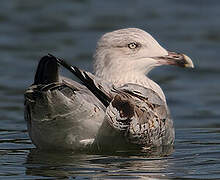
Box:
[57,54,174,149]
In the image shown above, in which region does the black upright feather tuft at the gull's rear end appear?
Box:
[34,55,59,85]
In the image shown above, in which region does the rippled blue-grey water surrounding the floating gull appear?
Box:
[0,0,220,179]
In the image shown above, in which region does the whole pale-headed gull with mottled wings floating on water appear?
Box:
[25,28,193,150]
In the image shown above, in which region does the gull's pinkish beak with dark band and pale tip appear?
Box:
[157,52,194,68]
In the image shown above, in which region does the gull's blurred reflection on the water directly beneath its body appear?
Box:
[25,146,174,179]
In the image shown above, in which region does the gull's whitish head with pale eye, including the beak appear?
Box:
[94,28,194,84]
